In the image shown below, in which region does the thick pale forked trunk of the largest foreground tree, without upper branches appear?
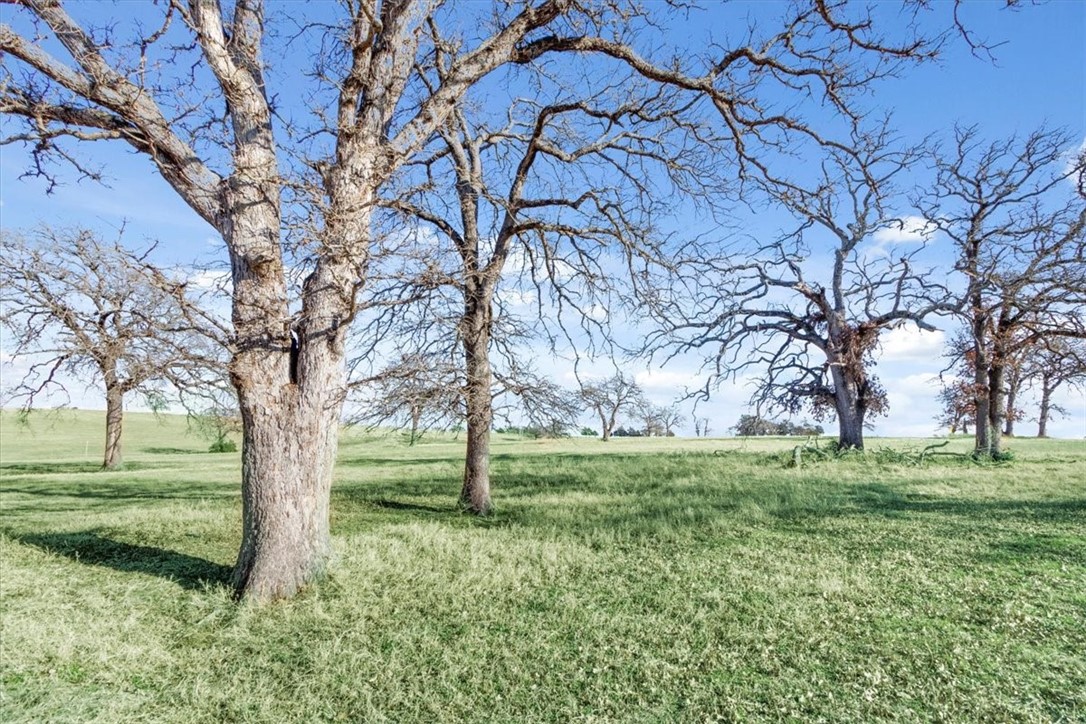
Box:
[224,158,360,601]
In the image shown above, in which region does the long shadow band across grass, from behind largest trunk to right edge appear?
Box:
[337,459,1086,547]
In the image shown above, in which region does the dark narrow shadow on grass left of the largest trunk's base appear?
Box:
[11,531,231,589]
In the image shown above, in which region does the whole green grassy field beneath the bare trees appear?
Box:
[0,412,1086,723]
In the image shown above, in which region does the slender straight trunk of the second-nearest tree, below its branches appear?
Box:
[460,294,494,516]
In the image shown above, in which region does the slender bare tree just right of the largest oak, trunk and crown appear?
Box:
[383,87,692,515]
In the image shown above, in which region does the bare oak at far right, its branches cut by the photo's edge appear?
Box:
[918,128,1086,457]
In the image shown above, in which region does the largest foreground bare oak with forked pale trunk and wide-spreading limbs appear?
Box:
[6,0,960,600]
